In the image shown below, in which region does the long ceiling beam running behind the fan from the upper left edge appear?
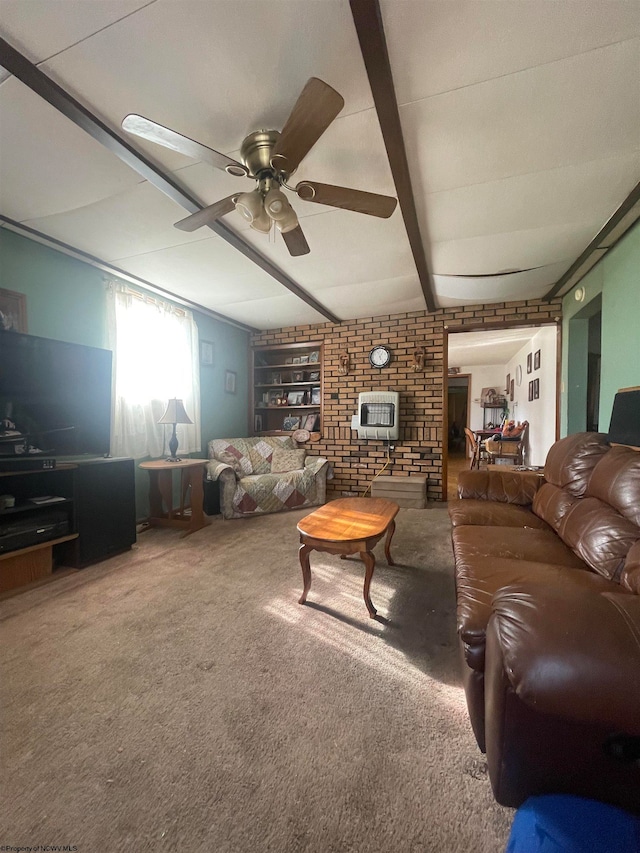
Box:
[0,38,340,323]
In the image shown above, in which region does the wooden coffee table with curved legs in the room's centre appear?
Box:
[298,498,399,619]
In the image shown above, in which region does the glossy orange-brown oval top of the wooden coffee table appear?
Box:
[298,498,400,542]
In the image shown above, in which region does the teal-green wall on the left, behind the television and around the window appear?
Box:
[0,228,249,518]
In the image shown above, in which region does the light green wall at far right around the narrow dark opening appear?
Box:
[561,222,640,435]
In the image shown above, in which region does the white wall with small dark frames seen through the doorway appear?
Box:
[502,326,557,465]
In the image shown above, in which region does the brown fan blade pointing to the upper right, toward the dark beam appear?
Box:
[271,77,344,175]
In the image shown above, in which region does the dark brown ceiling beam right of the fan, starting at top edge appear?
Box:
[349,0,437,311]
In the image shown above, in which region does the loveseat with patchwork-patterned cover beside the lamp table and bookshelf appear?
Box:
[207,436,329,518]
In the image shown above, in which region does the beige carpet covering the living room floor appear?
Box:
[0,505,513,853]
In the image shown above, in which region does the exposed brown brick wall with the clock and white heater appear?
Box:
[251,299,562,500]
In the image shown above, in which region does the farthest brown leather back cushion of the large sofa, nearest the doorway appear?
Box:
[544,432,610,497]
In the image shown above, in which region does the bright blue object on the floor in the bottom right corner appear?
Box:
[505,794,640,853]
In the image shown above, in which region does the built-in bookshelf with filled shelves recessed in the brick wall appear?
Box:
[250,341,323,435]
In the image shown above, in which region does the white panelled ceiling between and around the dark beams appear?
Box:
[0,0,640,329]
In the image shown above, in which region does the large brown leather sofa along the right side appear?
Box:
[449,433,640,813]
